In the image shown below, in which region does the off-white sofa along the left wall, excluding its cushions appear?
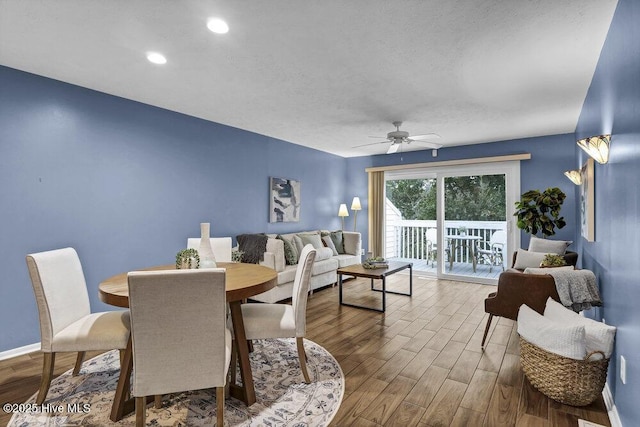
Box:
[252,230,362,303]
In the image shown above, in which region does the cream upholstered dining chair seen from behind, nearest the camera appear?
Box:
[128,268,232,426]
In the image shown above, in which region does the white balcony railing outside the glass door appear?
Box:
[385,220,507,268]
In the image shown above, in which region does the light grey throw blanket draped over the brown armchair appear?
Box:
[524,268,602,313]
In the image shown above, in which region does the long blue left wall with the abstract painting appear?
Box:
[0,67,346,351]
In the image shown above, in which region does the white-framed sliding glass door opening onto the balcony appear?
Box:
[384,162,520,283]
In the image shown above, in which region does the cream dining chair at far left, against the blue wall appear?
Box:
[27,248,129,404]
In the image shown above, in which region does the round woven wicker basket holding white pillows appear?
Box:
[520,337,609,406]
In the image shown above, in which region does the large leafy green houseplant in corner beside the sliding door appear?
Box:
[514,187,567,237]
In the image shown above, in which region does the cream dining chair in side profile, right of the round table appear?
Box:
[241,244,316,383]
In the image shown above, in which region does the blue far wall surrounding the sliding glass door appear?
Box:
[347,134,577,254]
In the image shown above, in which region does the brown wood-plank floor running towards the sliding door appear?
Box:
[0,274,611,427]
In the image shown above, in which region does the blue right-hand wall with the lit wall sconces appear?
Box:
[574,0,640,426]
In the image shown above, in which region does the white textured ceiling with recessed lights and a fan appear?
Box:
[0,0,617,157]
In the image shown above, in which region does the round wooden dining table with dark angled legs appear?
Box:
[98,262,277,422]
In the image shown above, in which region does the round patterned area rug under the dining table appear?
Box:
[8,339,344,427]
